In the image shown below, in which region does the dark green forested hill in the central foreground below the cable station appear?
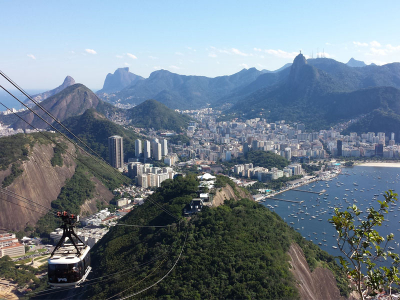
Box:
[70,175,347,299]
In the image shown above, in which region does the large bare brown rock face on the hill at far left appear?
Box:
[0,143,76,230]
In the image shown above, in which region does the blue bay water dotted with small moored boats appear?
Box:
[261,166,400,256]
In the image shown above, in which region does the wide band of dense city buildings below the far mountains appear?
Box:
[168,108,400,163]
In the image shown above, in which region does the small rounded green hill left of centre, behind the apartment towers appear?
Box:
[127,100,190,132]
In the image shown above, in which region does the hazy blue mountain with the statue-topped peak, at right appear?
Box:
[228,54,400,134]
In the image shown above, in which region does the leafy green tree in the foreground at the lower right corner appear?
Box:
[329,190,400,299]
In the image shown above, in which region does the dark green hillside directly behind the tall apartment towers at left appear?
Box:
[58,109,139,161]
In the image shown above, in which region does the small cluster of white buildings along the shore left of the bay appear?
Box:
[233,163,303,182]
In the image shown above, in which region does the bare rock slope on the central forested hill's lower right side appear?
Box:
[289,243,345,300]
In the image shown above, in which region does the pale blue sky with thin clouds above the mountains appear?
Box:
[0,0,400,90]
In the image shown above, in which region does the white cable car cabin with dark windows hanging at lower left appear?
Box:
[48,243,91,287]
